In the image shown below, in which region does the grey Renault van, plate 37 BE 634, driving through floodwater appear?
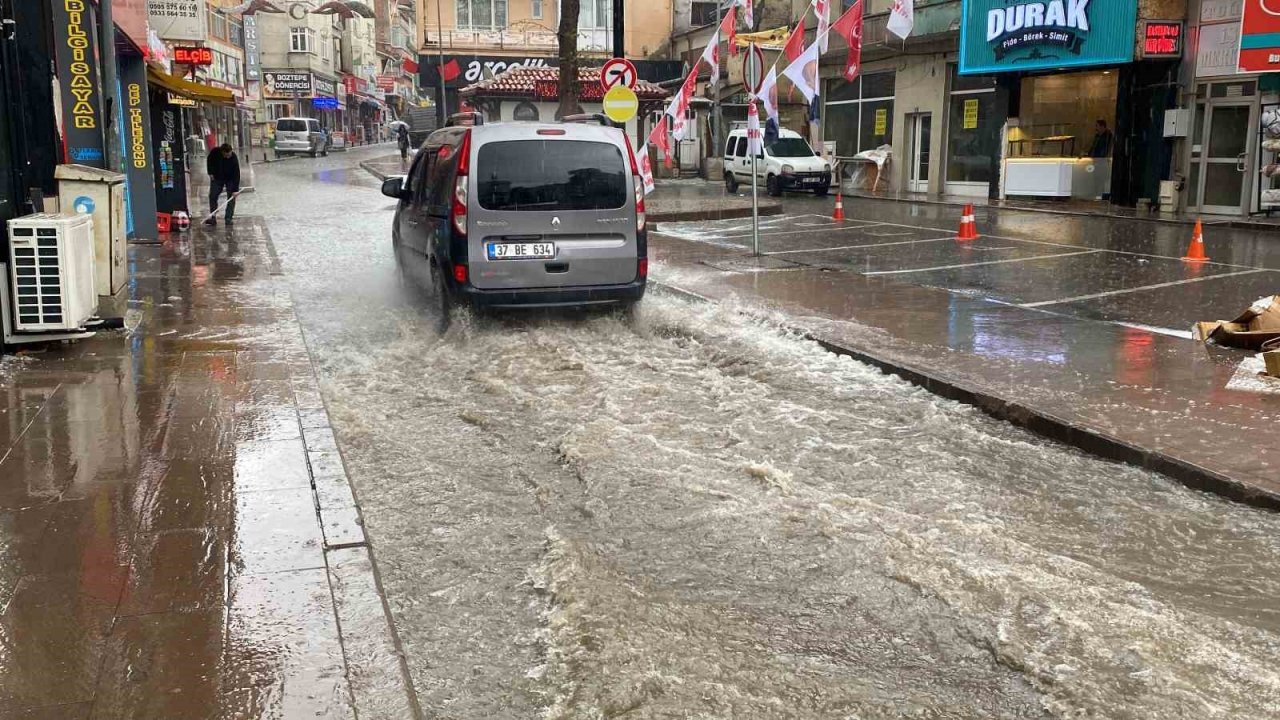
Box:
[383,114,649,310]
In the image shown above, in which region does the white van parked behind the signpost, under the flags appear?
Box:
[724,129,831,197]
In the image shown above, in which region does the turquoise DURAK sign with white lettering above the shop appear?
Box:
[960,0,1138,74]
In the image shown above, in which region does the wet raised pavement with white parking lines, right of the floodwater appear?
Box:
[650,210,1280,509]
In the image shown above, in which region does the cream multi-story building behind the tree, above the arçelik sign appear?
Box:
[417,0,672,120]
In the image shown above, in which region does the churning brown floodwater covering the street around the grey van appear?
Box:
[252,150,1280,719]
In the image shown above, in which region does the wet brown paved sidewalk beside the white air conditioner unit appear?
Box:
[0,218,416,720]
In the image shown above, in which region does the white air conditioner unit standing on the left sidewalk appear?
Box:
[9,213,97,332]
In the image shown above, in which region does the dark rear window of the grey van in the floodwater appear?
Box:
[476,140,627,211]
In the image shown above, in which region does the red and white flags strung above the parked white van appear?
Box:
[637,0,915,195]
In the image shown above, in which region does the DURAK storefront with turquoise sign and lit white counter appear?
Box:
[947,0,1178,205]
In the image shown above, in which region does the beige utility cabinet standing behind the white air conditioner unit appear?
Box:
[54,165,128,296]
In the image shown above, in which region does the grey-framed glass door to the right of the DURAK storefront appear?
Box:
[1192,102,1256,215]
